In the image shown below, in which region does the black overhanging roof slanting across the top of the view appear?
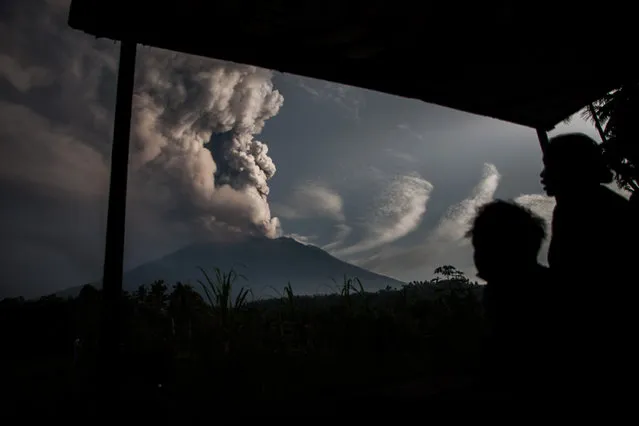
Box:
[69,0,637,130]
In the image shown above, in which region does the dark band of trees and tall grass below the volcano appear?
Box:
[0,266,483,401]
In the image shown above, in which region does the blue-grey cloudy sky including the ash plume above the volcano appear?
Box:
[0,0,620,298]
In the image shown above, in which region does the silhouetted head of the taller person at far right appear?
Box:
[540,133,613,196]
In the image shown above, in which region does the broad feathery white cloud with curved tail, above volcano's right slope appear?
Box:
[334,174,433,256]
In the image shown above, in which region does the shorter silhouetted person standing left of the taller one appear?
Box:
[468,200,552,396]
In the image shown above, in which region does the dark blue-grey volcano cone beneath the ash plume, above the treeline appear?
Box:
[64,238,403,298]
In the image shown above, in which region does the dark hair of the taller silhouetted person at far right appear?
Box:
[544,133,614,183]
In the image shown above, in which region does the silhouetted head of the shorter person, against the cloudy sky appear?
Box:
[467,200,546,282]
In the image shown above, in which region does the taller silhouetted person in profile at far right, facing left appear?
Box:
[541,134,639,395]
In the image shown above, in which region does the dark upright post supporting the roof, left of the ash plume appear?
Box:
[98,41,136,396]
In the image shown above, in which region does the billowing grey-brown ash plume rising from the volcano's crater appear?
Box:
[132,49,284,237]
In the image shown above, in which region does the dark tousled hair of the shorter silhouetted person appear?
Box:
[466,200,546,256]
